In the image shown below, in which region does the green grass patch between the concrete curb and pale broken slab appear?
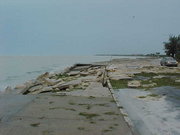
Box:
[110,80,129,89]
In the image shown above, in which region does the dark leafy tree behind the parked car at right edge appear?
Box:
[164,35,180,60]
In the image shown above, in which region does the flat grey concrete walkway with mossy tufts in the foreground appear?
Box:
[0,93,135,135]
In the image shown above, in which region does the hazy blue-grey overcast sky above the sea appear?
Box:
[0,0,180,55]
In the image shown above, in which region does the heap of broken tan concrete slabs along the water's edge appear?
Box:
[6,64,106,95]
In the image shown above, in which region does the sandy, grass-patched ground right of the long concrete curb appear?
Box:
[108,59,180,135]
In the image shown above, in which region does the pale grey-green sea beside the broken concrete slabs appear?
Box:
[0,56,141,91]
